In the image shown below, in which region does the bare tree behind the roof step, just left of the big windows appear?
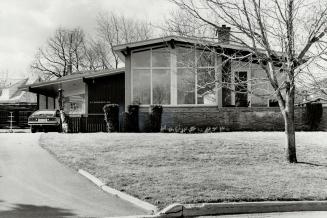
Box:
[97,13,153,68]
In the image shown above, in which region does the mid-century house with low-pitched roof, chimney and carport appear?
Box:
[21,26,327,131]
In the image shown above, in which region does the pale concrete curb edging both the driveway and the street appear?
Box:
[78,169,327,218]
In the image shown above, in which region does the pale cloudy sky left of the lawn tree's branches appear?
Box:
[0,0,174,78]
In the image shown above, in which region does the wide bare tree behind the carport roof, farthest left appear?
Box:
[31,28,85,78]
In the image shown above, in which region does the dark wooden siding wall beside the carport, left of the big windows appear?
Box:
[87,74,125,114]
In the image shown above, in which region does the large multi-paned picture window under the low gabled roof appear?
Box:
[131,46,217,105]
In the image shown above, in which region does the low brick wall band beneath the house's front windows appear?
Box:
[139,106,327,131]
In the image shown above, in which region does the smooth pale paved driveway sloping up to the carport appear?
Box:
[0,133,146,217]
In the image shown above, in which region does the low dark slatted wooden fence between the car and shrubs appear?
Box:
[68,115,106,133]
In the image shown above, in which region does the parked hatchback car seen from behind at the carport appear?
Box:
[28,110,61,133]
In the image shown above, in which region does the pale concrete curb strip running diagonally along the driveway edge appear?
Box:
[78,169,158,217]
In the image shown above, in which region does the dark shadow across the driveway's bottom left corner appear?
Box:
[0,201,76,218]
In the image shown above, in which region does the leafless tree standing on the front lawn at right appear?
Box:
[172,0,327,163]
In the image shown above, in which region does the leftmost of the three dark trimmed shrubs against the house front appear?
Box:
[103,104,119,132]
